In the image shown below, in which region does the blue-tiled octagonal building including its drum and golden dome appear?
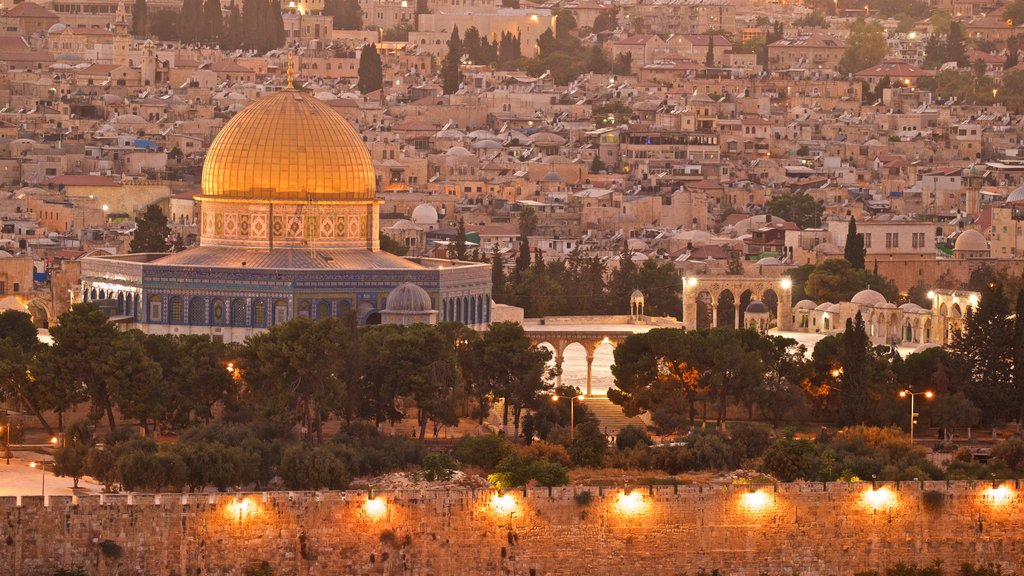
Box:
[79,88,490,341]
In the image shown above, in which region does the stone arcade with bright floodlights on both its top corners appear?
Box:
[683,276,793,330]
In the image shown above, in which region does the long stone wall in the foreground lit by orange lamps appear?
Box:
[0,482,1024,576]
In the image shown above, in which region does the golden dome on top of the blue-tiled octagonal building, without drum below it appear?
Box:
[203,89,377,202]
